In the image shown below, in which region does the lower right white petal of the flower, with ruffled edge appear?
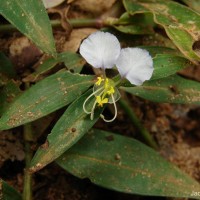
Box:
[116,48,154,85]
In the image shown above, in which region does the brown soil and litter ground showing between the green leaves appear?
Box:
[0,0,200,200]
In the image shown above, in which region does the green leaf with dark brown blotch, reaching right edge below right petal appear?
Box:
[121,75,200,104]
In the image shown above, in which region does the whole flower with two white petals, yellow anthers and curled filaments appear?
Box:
[80,31,154,122]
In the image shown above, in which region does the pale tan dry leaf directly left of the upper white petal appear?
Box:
[63,28,97,52]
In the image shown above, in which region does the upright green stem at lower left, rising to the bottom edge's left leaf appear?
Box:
[23,124,32,200]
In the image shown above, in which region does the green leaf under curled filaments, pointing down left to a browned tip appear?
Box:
[30,90,102,172]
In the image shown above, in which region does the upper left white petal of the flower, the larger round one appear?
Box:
[80,31,121,69]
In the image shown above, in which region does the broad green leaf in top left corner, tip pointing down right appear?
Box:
[0,0,56,56]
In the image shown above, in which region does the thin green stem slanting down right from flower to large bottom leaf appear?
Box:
[119,99,158,150]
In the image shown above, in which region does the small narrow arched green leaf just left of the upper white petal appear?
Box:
[24,52,85,81]
